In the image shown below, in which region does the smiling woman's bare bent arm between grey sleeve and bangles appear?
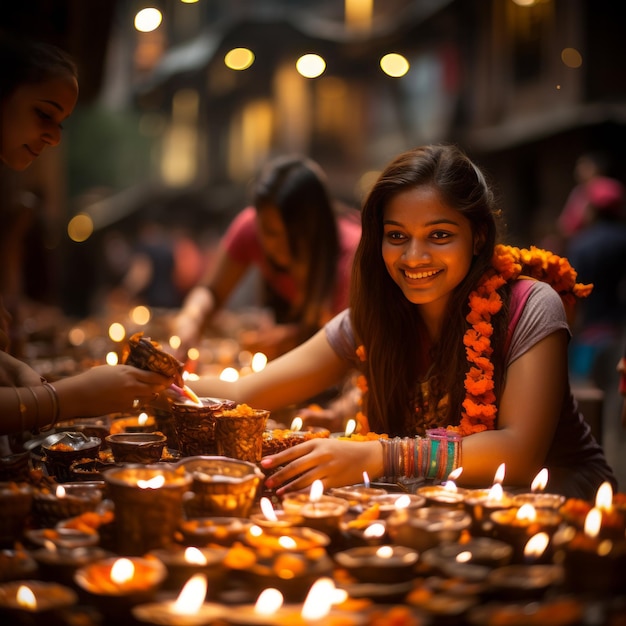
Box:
[458,330,568,486]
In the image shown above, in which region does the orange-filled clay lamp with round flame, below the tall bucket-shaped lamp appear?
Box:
[74,557,167,619]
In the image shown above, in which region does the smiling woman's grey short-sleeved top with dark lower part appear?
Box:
[326,281,617,499]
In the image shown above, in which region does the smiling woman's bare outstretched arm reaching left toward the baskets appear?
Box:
[188,329,351,411]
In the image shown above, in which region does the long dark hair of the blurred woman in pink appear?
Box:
[253,155,339,333]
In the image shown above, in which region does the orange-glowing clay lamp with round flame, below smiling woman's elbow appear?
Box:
[491,504,561,563]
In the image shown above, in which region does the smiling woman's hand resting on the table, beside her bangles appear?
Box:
[261,439,383,496]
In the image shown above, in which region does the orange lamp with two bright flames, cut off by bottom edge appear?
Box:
[227,577,367,626]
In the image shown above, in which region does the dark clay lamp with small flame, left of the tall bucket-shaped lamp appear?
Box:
[33,482,102,527]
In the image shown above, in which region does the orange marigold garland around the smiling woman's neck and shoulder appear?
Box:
[357,245,593,436]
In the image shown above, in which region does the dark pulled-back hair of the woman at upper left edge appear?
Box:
[0,31,78,104]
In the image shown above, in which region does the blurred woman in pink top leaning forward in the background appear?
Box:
[174,155,361,358]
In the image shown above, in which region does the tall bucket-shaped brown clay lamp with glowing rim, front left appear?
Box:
[104,463,191,556]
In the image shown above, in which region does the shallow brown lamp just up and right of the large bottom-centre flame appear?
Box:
[333,545,419,584]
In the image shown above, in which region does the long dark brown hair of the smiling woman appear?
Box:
[350,145,508,435]
